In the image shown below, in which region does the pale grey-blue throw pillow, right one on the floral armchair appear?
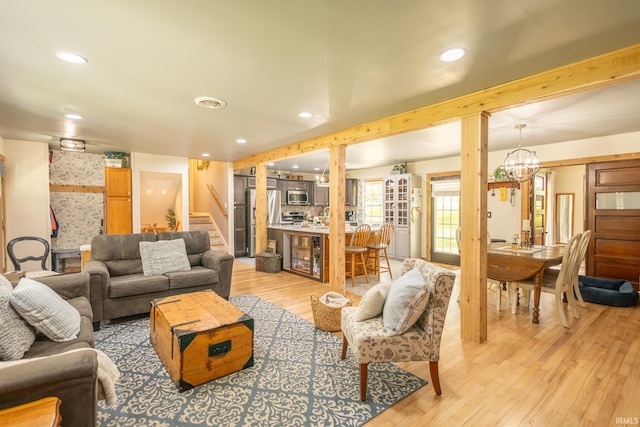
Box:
[382,268,429,335]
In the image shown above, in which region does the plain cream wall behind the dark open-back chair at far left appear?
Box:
[4,140,51,271]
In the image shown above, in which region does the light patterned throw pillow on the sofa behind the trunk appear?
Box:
[140,239,191,276]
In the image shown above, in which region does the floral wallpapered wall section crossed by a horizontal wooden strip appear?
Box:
[49,151,104,254]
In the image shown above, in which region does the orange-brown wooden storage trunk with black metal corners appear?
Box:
[150,290,253,392]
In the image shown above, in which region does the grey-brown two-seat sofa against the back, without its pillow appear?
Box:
[82,231,234,329]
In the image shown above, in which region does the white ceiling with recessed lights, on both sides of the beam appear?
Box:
[0,0,640,171]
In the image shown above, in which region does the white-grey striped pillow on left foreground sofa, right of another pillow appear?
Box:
[11,278,80,342]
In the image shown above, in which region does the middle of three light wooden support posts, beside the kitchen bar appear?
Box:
[324,145,347,294]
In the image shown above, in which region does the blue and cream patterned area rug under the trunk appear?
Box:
[95,295,426,427]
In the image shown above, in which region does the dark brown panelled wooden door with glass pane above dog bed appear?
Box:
[586,159,640,289]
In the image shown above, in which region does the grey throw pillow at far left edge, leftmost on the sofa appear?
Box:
[0,274,36,360]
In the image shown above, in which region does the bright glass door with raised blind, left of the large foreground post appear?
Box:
[431,176,460,264]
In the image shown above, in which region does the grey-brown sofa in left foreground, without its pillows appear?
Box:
[0,273,98,427]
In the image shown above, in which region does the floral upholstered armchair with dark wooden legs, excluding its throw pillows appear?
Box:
[340,258,456,401]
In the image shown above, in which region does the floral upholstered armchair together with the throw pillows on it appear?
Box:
[341,258,456,401]
